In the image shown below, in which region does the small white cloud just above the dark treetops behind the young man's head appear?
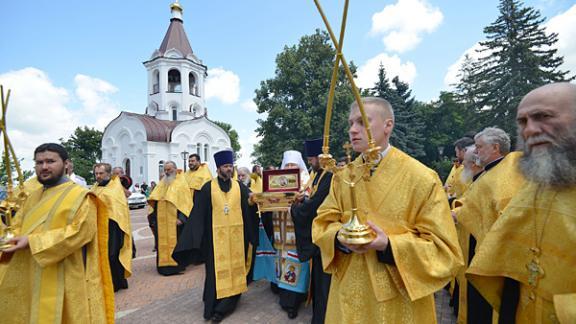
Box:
[356,53,416,88]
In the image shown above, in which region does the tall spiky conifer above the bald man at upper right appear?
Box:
[460,0,573,134]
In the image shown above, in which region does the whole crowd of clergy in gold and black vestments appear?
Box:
[0,83,576,324]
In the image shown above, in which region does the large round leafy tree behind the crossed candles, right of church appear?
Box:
[253,30,356,165]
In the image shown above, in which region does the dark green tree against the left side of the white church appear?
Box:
[60,126,102,183]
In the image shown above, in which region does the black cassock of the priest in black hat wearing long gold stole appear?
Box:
[172,177,258,319]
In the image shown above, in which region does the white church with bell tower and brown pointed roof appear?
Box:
[102,1,231,183]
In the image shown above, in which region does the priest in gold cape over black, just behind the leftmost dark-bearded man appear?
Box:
[91,163,132,291]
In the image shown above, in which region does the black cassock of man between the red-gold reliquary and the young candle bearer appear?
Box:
[291,172,332,323]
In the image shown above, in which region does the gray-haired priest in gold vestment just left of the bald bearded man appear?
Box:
[453,127,524,323]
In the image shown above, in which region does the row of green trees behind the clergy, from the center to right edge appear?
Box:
[254,0,574,176]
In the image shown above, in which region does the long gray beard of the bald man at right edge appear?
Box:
[518,129,576,187]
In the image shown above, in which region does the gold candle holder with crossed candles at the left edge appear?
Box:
[0,85,27,251]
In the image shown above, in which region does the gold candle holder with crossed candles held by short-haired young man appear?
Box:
[314,0,381,244]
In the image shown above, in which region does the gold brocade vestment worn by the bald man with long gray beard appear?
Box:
[466,182,576,323]
